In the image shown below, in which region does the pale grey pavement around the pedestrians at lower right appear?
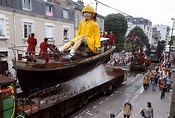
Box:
[116,84,172,118]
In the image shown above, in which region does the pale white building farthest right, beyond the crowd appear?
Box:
[154,24,170,43]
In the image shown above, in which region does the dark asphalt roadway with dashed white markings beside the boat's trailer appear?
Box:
[68,71,144,118]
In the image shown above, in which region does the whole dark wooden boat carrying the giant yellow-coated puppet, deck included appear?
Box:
[12,38,115,92]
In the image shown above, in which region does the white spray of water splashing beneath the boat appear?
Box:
[62,65,109,93]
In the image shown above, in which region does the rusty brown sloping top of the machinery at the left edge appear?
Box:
[0,74,16,86]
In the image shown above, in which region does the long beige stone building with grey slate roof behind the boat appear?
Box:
[0,0,75,64]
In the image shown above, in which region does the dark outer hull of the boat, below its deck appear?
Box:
[15,49,114,92]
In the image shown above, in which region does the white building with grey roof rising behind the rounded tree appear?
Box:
[126,16,152,43]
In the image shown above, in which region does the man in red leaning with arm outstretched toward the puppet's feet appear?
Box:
[39,38,54,63]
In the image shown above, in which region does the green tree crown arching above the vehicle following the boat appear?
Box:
[127,26,149,46]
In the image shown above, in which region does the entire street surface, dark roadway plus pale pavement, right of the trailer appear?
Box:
[69,64,171,118]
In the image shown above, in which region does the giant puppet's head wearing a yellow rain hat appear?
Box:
[82,5,96,20]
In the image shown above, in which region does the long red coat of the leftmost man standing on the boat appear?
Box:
[27,36,37,54]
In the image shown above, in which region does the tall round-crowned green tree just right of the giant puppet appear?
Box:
[104,13,128,52]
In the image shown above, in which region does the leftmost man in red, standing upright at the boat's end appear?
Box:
[27,33,37,62]
